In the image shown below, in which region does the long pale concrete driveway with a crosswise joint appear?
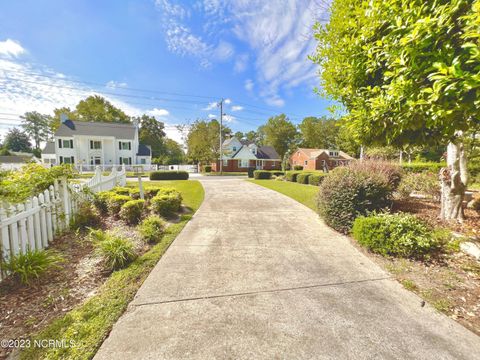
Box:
[96,178,480,359]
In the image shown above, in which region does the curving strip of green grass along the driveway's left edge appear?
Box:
[20,180,204,359]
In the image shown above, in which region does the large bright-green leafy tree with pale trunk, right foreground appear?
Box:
[311,0,480,220]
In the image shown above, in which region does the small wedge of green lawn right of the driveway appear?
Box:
[248,180,318,211]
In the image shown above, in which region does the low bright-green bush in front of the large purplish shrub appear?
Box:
[352,213,440,258]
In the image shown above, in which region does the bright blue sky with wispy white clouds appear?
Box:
[0,0,330,140]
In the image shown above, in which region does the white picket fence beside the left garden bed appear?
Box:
[0,166,126,281]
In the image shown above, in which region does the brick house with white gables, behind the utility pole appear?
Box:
[212,137,282,172]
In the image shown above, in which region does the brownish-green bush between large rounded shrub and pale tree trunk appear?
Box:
[397,172,440,200]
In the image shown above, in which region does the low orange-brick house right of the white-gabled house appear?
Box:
[289,148,354,170]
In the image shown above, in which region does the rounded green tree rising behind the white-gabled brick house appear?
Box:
[258,114,297,159]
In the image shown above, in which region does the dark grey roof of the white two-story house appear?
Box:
[55,120,135,140]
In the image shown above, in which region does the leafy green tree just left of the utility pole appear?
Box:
[187,120,232,163]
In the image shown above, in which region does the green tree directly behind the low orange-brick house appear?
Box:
[298,116,343,150]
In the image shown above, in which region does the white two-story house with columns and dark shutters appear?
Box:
[42,119,152,170]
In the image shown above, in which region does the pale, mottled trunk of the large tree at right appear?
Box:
[440,141,468,221]
